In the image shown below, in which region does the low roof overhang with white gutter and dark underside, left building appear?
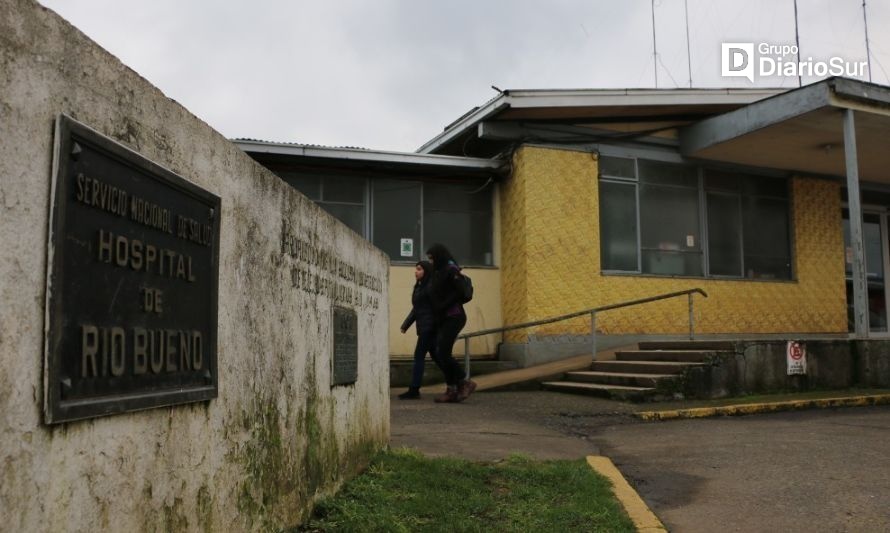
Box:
[232,139,506,176]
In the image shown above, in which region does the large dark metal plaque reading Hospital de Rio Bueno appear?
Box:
[44,115,220,424]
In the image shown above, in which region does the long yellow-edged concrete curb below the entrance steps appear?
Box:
[634,394,890,421]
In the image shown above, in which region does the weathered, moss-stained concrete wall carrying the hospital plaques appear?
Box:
[0,0,389,531]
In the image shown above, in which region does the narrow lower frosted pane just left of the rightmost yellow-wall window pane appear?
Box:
[708,193,742,276]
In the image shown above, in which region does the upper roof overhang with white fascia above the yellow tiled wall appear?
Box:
[417,88,786,154]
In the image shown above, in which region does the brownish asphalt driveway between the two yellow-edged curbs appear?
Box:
[588,407,890,532]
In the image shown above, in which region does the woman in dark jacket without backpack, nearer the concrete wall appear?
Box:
[399,261,436,400]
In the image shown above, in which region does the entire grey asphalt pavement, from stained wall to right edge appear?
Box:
[391,391,890,532]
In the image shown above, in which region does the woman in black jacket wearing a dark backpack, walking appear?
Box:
[426,244,476,403]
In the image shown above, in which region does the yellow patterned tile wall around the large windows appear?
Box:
[501,146,847,342]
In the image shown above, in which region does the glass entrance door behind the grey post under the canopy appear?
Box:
[844,209,890,336]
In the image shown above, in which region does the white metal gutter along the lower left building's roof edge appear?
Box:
[232,140,505,170]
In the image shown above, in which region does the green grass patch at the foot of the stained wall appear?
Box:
[296,449,634,532]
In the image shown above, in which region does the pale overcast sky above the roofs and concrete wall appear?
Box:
[40,0,890,151]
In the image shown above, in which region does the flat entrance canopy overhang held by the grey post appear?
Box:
[680,78,890,183]
